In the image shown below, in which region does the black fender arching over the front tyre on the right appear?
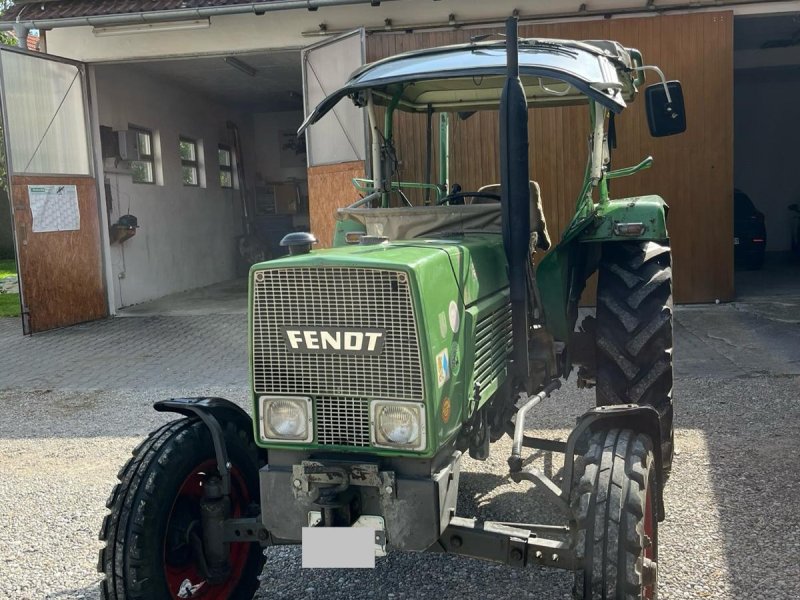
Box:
[561,404,665,521]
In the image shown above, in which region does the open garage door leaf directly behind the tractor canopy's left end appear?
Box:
[303,29,367,246]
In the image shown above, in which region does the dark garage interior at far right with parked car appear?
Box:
[734,13,800,299]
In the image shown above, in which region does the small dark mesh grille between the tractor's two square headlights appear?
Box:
[314,398,369,447]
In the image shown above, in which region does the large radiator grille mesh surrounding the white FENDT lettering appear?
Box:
[252,267,423,401]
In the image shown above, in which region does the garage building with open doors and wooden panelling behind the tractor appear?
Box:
[0,0,800,332]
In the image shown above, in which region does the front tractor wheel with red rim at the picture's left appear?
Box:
[98,419,265,600]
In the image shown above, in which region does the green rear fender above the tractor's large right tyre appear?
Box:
[578,195,669,243]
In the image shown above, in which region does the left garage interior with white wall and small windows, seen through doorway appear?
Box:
[94,51,308,315]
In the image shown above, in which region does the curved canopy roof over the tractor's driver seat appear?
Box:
[298,39,642,133]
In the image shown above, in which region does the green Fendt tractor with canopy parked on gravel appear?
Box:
[99,19,686,600]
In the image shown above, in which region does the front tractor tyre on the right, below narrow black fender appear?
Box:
[570,429,658,600]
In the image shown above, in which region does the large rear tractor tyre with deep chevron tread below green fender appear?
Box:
[595,242,673,477]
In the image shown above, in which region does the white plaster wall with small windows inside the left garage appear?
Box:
[96,65,253,308]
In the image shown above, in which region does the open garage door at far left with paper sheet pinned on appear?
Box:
[0,48,108,333]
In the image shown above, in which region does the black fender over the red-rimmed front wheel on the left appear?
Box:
[153,397,262,494]
